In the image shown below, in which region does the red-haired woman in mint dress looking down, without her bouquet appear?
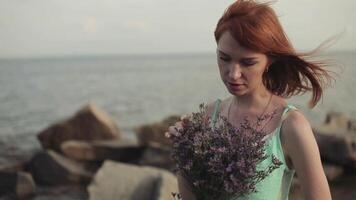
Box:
[169,0,332,200]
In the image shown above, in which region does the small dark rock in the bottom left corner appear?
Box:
[0,171,36,199]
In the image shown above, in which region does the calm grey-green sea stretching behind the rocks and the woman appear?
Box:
[0,52,356,165]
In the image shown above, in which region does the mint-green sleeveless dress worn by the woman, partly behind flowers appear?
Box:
[212,99,297,200]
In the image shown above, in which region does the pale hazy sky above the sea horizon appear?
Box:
[0,0,356,58]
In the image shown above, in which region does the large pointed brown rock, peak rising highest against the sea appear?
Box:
[38,103,121,152]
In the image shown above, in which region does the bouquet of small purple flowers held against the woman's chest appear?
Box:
[167,104,281,200]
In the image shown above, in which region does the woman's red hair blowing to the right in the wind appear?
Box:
[214,0,334,108]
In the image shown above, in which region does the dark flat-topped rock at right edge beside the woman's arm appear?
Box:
[314,132,356,166]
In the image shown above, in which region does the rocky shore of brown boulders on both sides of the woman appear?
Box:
[0,103,356,200]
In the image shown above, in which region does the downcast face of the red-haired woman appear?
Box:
[217,31,270,96]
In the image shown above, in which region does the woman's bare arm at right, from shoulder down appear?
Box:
[282,111,331,200]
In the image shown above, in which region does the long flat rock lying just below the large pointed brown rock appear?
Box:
[61,139,145,162]
